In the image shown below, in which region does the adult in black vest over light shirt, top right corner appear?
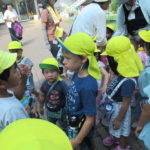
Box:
[113,0,150,42]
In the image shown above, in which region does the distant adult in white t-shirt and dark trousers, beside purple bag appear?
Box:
[4,3,18,41]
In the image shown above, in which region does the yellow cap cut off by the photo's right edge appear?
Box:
[139,30,150,43]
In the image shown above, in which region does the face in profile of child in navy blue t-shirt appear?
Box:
[63,51,83,71]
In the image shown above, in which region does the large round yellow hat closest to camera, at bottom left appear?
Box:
[0,119,72,150]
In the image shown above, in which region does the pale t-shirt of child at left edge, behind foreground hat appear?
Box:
[0,91,29,132]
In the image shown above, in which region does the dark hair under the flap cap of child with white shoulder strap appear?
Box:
[107,56,119,75]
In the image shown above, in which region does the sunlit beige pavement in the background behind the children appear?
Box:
[0,21,70,88]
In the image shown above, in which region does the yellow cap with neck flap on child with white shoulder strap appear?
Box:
[101,36,143,78]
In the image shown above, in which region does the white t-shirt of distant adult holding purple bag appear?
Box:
[3,9,18,28]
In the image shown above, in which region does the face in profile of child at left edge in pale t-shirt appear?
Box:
[6,64,21,88]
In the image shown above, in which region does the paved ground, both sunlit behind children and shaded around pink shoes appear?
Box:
[0,21,145,150]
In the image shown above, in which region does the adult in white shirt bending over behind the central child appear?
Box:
[71,0,110,47]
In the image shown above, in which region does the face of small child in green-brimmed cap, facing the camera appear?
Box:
[43,69,59,83]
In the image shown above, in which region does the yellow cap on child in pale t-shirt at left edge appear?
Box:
[0,51,17,74]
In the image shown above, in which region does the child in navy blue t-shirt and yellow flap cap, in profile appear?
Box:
[60,33,101,150]
